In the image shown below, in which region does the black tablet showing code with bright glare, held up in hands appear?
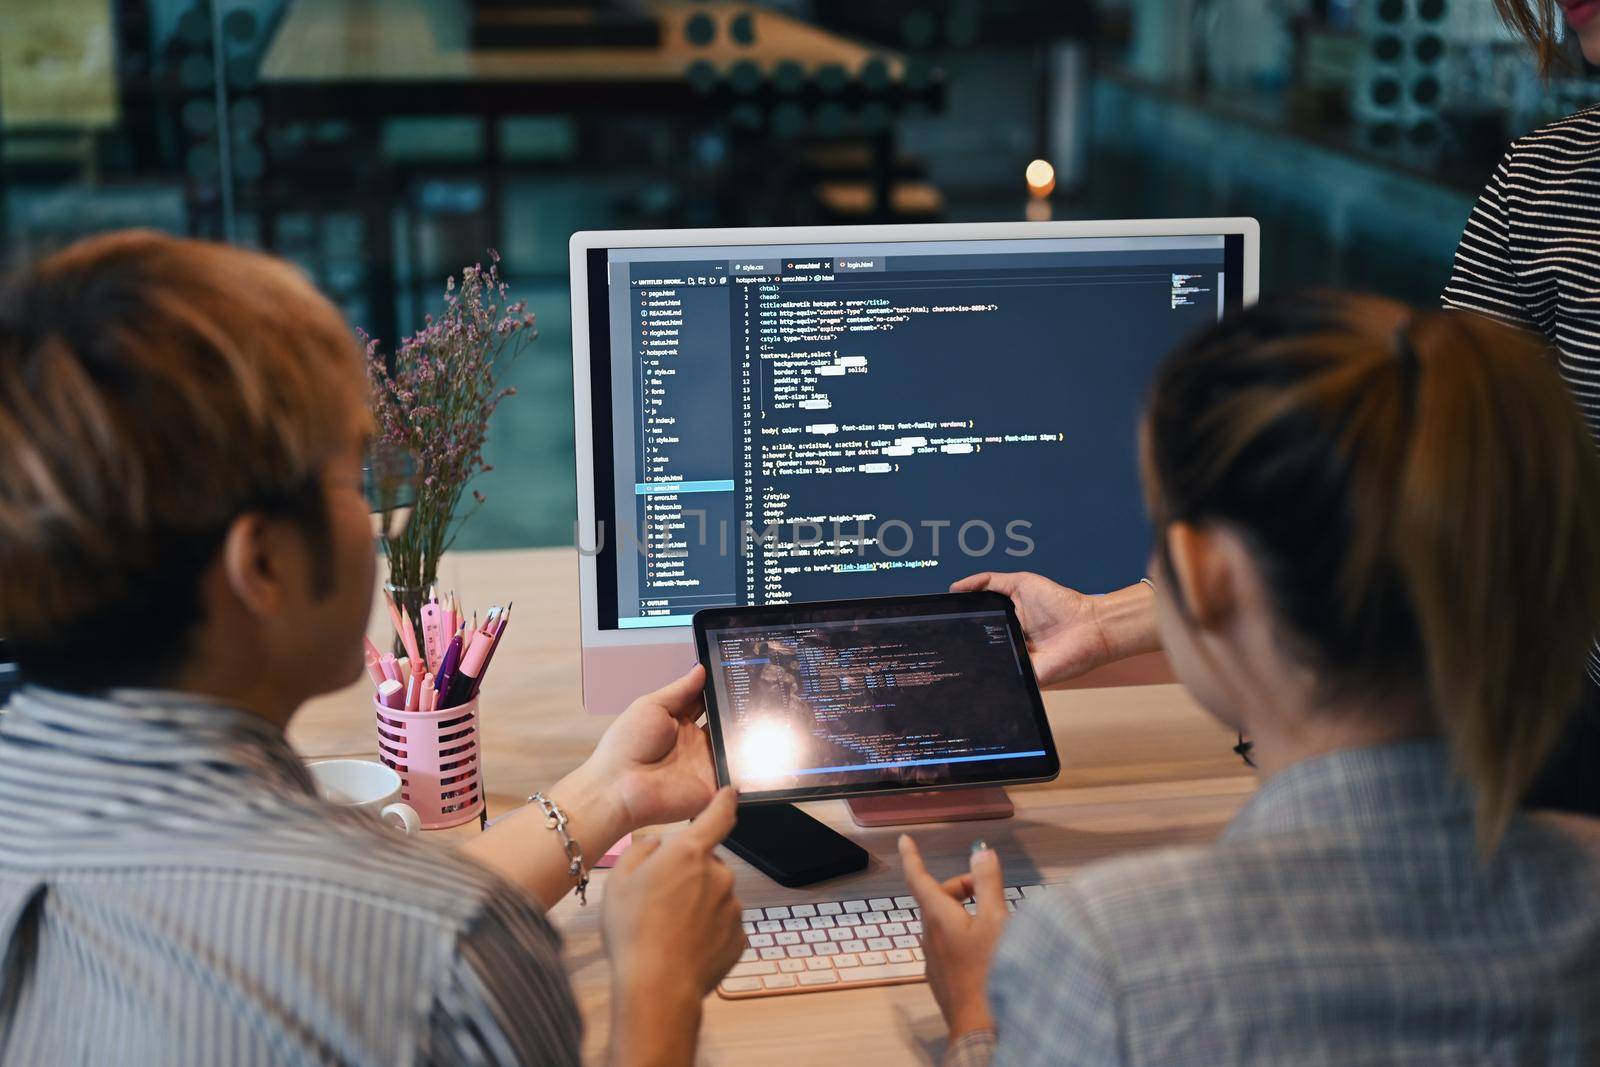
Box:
[694,592,1061,801]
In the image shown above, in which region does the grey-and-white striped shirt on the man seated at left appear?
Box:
[0,688,579,1067]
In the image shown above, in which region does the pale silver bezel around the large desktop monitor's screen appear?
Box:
[568,216,1261,649]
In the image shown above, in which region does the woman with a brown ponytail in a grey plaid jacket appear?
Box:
[901,294,1600,1065]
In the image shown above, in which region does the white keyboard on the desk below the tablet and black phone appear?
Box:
[717,885,1045,1000]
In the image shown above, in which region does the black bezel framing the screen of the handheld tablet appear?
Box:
[691,590,1061,805]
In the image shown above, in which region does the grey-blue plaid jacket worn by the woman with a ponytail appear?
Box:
[946,741,1600,1067]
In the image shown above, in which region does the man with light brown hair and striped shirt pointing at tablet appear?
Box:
[0,232,744,1067]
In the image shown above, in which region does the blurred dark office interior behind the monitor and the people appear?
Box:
[0,0,1600,547]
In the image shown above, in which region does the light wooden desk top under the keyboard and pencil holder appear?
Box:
[290,549,1256,1067]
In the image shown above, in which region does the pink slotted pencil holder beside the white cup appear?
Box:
[373,697,483,830]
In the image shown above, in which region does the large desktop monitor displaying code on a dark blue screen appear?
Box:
[571,218,1259,713]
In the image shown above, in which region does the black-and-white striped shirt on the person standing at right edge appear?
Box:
[1445,106,1600,685]
